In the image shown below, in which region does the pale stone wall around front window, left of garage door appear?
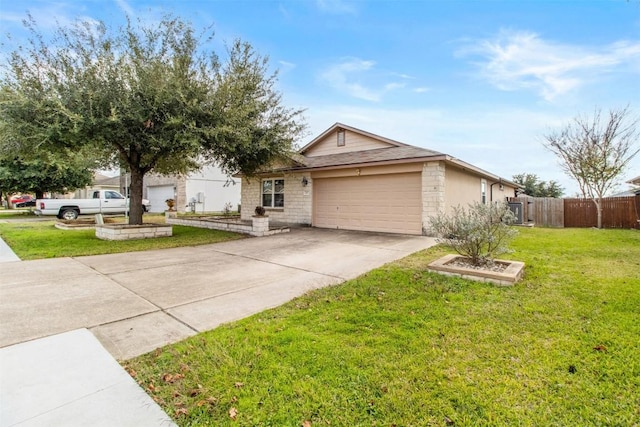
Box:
[241,173,313,225]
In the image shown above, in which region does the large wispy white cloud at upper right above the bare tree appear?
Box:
[456,31,640,101]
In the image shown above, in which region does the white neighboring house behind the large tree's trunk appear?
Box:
[142,166,240,213]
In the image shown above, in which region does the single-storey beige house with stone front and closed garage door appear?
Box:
[242,123,518,234]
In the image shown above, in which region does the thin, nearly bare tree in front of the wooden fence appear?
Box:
[544,106,640,228]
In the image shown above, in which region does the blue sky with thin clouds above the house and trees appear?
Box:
[0,0,640,196]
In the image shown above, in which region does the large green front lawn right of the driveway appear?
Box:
[124,229,640,426]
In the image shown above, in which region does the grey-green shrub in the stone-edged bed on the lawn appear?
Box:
[430,202,517,266]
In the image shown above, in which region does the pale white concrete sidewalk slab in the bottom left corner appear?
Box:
[0,329,175,427]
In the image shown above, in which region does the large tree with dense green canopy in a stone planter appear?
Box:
[0,16,304,224]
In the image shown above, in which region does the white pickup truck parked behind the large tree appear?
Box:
[34,190,149,220]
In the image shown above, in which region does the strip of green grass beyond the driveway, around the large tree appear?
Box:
[0,215,243,260]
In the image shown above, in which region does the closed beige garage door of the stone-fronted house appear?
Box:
[313,173,422,234]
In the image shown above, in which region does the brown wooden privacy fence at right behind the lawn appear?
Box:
[509,195,640,229]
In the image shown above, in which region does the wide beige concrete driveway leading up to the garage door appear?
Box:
[0,228,435,360]
